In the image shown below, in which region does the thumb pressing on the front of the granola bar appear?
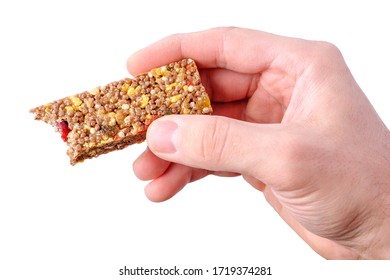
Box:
[147,115,276,175]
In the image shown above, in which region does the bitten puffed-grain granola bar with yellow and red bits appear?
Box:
[31,59,212,165]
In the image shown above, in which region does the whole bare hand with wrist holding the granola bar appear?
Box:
[127,28,390,259]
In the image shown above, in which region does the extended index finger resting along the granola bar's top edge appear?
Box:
[127,27,288,75]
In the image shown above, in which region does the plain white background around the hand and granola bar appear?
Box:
[0,0,390,280]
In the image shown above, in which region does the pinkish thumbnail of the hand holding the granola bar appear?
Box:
[147,120,178,154]
